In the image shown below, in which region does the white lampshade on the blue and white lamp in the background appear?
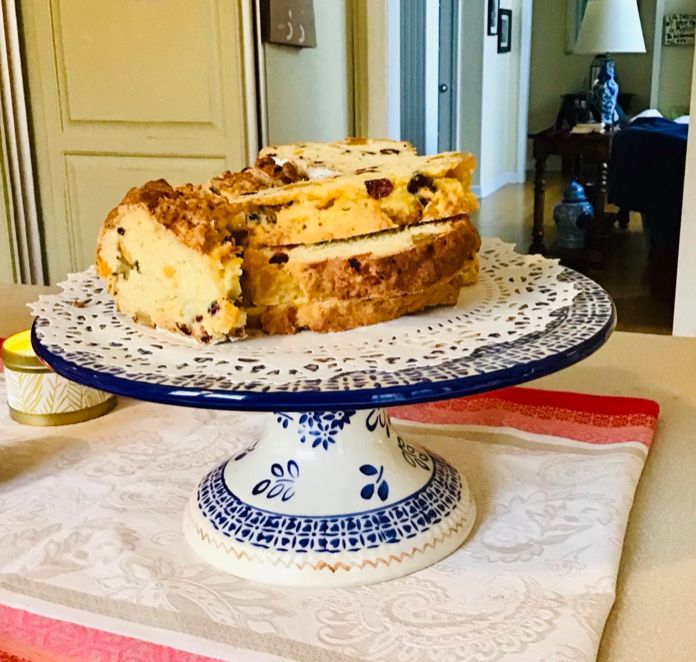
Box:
[575,0,645,53]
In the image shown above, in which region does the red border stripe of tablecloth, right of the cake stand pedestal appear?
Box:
[390,388,659,446]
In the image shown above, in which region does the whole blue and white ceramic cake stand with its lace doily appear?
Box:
[32,240,615,586]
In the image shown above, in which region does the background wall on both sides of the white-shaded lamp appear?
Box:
[529,0,655,131]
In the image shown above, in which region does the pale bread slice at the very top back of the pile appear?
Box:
[257,138,416,179]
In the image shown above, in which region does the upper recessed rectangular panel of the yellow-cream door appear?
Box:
[57,0,222,125]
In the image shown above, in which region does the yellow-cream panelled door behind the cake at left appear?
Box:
[21,0,256,282]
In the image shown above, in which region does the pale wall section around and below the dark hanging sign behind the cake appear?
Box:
[264,0,353,144]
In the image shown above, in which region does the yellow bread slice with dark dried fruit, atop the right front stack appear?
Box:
[210,152,478,247]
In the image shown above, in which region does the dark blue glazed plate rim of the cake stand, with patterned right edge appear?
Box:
[31,269,616,412]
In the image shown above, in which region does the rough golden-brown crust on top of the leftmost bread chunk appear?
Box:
[102,179,241,253]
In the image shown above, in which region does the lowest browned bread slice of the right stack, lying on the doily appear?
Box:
[247,255,479,334]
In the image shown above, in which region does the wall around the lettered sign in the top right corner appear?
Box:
[658,0,696,116]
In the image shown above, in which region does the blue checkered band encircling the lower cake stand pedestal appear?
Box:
[197,455,462,553]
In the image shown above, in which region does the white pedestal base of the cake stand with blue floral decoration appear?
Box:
[184,409,476,587]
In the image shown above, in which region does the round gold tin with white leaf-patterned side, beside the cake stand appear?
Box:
[2,330,116,425]
